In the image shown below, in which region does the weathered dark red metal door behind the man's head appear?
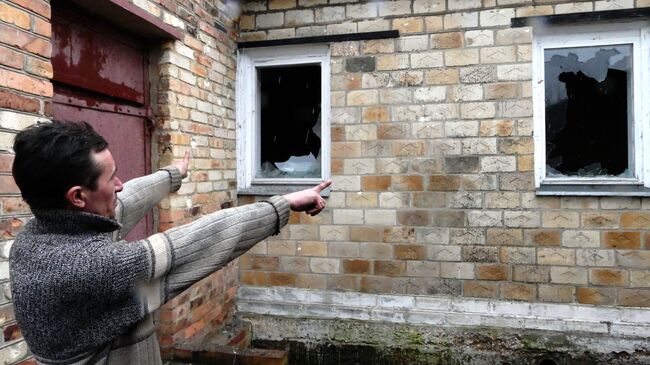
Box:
[52,1,153,239]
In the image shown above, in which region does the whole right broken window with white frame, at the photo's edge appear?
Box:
[533,22,650,195]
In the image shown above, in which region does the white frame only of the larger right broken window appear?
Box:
[533,22,650,195]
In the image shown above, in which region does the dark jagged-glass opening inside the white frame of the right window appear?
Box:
[544,44,633,177]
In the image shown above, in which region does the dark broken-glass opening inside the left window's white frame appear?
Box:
[257,65,321,178]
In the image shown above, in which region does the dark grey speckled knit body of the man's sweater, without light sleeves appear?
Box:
[10,228,150,358]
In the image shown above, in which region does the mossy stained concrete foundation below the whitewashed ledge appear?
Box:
[239,314,650,365]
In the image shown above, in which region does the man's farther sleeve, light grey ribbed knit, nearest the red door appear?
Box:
[115,166,182,237]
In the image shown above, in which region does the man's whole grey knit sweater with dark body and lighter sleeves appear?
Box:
[10,167,289,365]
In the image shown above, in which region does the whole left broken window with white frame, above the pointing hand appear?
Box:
[236,44,331,195]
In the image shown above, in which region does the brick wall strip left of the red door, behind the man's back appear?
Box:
[0,0,52,364]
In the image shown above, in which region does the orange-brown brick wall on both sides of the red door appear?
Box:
[0,0,237,364]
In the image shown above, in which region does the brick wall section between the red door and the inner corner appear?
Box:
[149,1,238,357]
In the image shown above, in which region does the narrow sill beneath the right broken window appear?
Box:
[535,185,650,197]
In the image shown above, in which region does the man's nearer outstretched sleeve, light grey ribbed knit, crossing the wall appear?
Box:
[133,196,289,311]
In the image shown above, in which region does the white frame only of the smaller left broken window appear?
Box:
[236,44,331,194]
